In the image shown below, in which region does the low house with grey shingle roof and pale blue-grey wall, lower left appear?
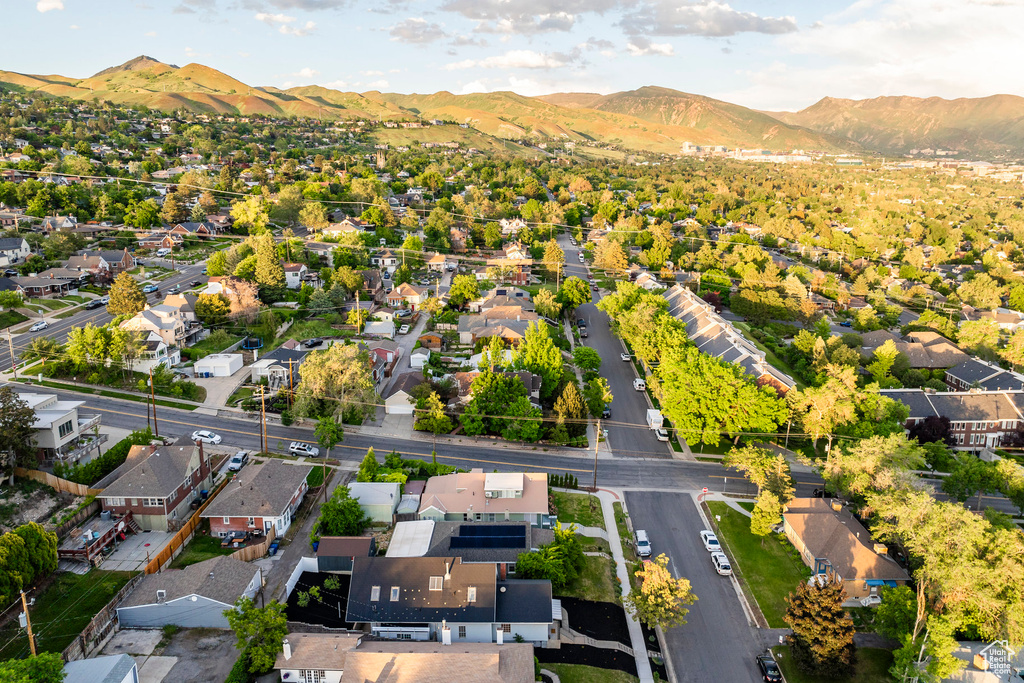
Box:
[118,555,263,629]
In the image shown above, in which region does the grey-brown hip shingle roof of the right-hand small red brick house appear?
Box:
[203,458,312,517]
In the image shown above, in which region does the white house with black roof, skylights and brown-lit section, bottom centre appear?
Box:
[345,556,554,647]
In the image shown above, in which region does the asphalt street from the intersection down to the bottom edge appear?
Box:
[626,492,763,683]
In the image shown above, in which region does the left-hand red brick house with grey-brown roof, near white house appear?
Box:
[96,436,213,531]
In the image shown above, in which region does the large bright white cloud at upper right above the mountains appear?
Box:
[710,0,1024,110]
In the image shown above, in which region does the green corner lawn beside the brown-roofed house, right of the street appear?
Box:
[708,501,810,629]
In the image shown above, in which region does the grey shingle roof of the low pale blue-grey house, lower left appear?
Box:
[118,555,259,607]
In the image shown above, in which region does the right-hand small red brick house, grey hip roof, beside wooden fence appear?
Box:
[203,458,312,538]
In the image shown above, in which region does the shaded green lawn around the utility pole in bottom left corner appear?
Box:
[0,569,131,659]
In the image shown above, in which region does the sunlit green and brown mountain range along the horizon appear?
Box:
[0,55,1024,158]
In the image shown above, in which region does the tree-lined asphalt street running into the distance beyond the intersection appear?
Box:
[558,229,670,458]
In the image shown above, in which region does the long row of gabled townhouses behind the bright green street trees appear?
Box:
[662,285,797,394]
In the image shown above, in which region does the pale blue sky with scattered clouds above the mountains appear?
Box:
[8,0,1024,110]
